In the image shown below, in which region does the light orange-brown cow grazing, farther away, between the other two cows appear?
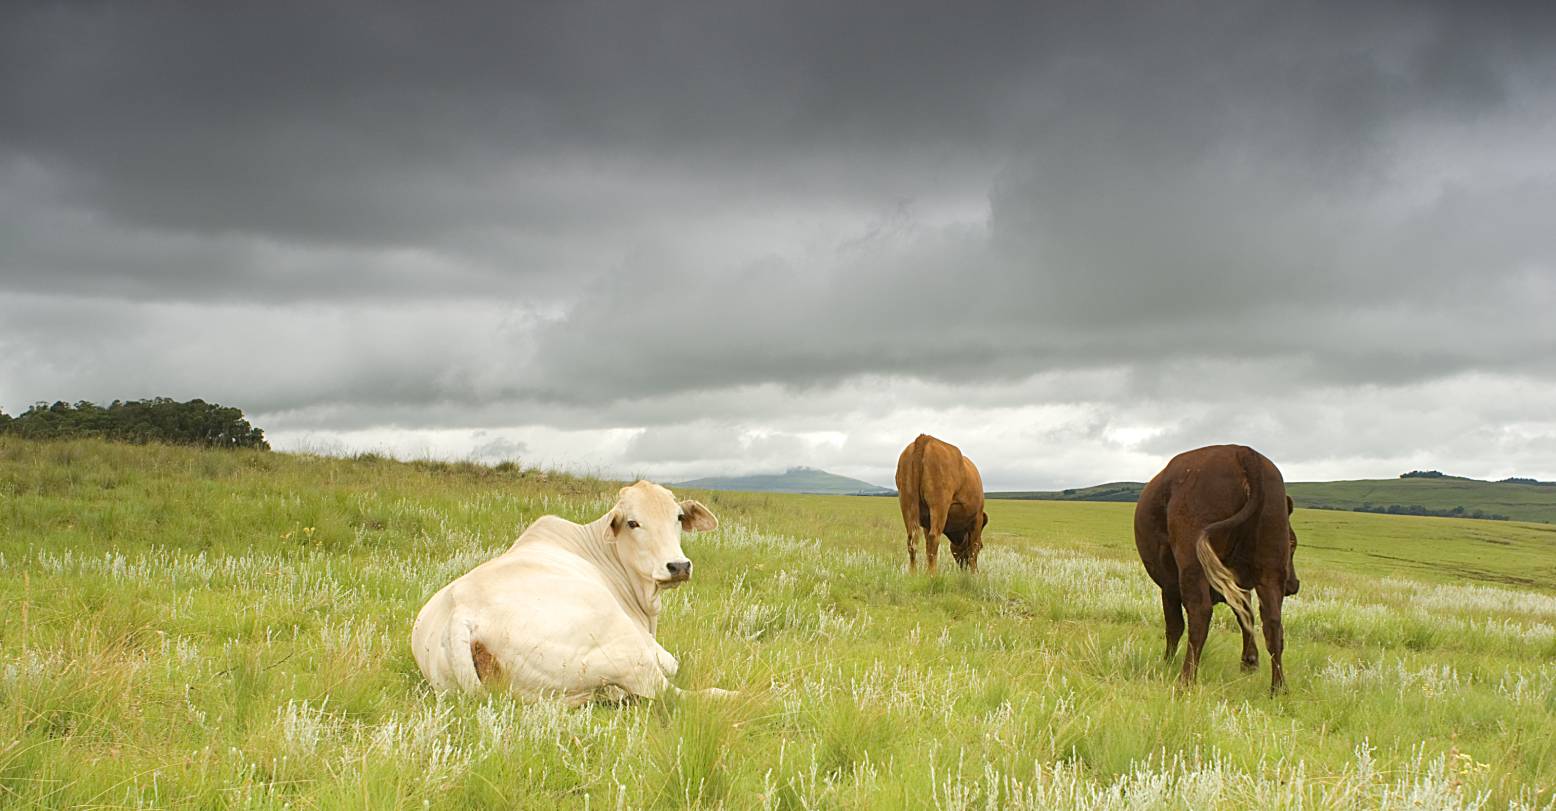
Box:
[896,434,988,573]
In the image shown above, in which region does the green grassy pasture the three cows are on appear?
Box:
[9,437,1556,809]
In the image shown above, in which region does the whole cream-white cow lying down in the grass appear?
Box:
[411,481,719,704]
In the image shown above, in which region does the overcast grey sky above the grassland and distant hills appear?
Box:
[0,0,1556,489]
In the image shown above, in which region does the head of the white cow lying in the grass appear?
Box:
[610,481,719,588]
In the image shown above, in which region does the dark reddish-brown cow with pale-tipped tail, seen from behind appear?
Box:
[1134,445,1301,693]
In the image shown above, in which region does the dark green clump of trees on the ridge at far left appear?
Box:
[0,397,269,450]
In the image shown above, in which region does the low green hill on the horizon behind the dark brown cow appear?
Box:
[988,476,1556,523]
